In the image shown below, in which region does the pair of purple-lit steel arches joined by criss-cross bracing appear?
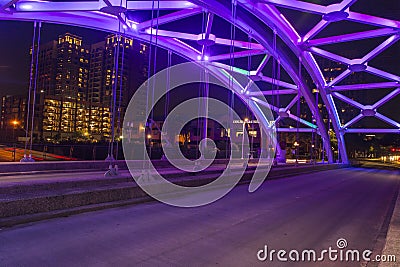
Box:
[0,0,400,162]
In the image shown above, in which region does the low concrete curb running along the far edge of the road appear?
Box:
[0,165,348,227]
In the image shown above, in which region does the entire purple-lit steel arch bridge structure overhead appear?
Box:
[0,0,400,163]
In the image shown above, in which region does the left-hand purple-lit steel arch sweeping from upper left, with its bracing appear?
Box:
[0,0,333,162]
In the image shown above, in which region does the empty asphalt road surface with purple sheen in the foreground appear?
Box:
[0,168,400,266]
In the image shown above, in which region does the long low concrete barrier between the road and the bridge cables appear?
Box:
[0,164,347,226]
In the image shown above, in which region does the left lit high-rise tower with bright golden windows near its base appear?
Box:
[44,33,89,139]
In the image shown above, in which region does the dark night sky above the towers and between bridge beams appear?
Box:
[0,0,400,102]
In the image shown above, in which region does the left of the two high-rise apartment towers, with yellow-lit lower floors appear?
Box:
[34,33,89,140]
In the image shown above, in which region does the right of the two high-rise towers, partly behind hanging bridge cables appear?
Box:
[87,34,148,141]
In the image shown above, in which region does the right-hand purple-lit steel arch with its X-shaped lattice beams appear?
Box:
[234,0,400,162]
